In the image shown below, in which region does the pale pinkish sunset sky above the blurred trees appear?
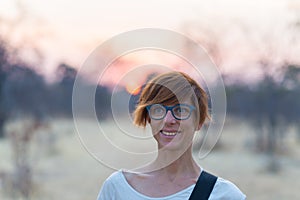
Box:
[0,0,300,85]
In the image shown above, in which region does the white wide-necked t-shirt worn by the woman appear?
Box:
[97,171,246,200]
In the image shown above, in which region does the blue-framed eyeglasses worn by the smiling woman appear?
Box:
[146,104,196,120]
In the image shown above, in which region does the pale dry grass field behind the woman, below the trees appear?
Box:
[0,119,300,200]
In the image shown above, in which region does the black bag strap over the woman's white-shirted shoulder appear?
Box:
[189,170,218,200]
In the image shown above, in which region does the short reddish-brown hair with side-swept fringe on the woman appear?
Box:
[134,71,210,127]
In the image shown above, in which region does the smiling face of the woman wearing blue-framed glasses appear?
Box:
[150,100,200,150]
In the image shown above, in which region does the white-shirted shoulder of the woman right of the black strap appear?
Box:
[210,177,246,200]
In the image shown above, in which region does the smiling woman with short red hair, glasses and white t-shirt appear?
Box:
[98,72,246,200]
